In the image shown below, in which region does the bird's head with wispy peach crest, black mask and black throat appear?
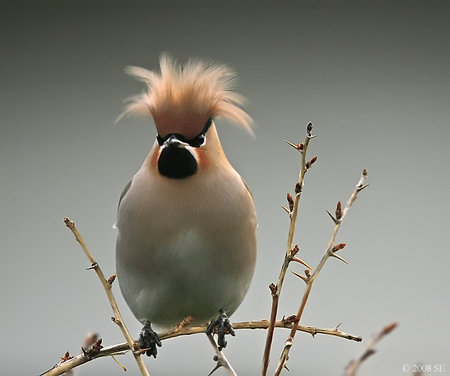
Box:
[117,54,253,179]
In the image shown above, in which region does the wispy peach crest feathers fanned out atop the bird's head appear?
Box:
[120,54,253,133]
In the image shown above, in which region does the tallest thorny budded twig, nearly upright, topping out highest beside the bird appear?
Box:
[261,122,317,376]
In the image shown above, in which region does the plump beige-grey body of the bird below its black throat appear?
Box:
[116,160,256,326]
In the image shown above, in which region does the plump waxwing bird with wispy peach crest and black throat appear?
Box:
[115,53,257,358]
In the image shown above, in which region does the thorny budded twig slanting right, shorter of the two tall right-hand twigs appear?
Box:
[275,169,367,376]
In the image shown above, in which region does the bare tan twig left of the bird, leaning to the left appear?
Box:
[64,218,149,376]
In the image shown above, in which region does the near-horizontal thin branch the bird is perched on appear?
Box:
[43,316,362,376]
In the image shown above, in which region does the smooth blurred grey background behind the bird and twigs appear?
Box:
[0,0,450,376]
